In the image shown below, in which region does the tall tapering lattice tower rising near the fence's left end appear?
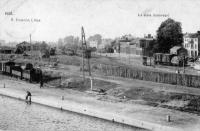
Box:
[81,27,91,80]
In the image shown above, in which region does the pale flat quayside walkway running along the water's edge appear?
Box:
[0,79,200,131]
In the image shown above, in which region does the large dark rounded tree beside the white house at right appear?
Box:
[154,18,183,53]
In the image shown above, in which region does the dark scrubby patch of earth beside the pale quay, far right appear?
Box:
[118,87,200,115]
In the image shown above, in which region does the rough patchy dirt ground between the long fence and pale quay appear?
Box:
[39,68,200,115]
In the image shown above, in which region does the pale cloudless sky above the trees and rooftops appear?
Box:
[0,0,200,42]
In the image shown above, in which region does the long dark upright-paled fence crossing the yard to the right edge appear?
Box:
[96,64,200,88]
